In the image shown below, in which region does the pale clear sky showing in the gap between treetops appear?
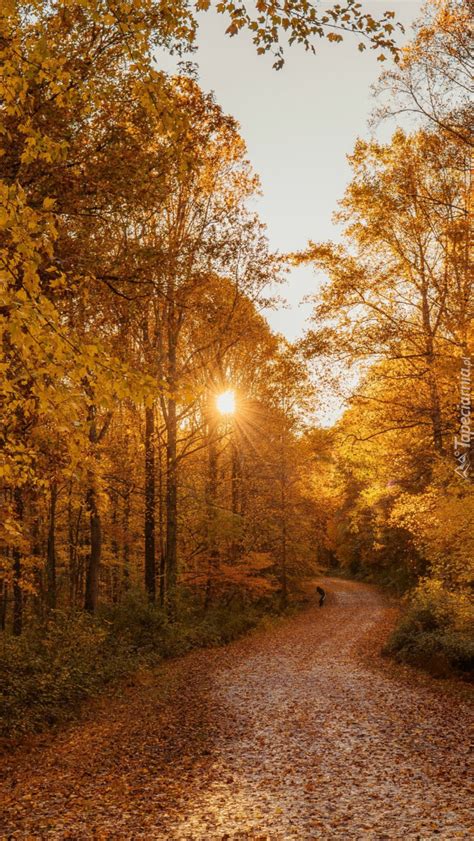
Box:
[160,0,421,339]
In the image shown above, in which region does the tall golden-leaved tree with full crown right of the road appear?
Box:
[297,80,473,636]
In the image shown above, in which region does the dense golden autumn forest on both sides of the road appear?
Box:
[0,0,474,732]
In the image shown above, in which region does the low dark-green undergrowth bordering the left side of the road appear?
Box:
[0,592,270,736]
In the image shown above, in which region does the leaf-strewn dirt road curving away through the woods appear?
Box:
[0,580,473,841]
